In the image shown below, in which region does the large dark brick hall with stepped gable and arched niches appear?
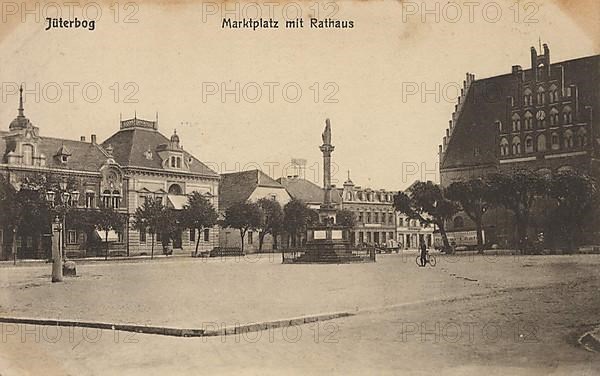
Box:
[439,45,600,245]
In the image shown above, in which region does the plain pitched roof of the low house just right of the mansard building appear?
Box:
[219,170,285,209]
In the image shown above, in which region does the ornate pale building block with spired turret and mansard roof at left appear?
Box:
[0,89,220,259]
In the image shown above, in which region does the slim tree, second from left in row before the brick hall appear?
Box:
[446,179,491,253]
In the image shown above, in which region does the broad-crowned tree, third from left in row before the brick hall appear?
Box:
[488,171,547,252]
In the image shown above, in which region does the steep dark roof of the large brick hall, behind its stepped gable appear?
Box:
[440,50,600,170]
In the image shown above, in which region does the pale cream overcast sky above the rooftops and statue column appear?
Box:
[0,0,600,190]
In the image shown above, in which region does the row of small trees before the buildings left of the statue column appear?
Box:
[0,175,354,257]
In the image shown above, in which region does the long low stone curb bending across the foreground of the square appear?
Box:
[0,312,353,337]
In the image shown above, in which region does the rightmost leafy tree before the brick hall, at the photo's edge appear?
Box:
[548,171,598,252]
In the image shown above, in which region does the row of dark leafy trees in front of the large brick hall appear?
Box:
[394,170,600,252]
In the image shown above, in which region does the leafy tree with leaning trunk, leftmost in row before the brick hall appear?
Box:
[394,181,458,251]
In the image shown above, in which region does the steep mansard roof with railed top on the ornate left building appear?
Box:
[102,119,219,177]
